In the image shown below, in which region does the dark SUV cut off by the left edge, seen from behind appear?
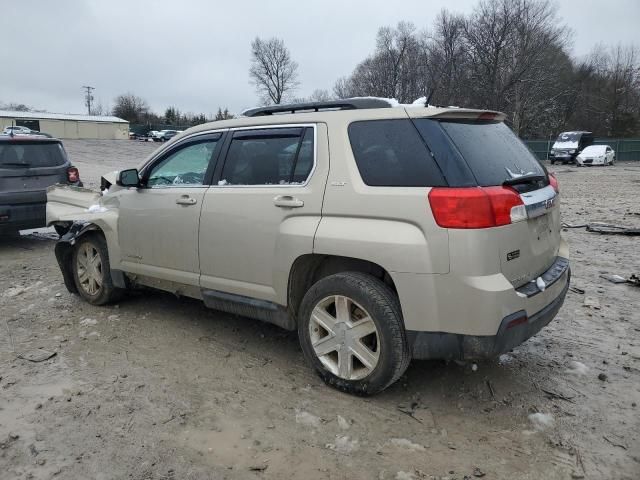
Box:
[0,135,82,234]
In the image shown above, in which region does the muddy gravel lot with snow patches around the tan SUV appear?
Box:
[0,141,640,480]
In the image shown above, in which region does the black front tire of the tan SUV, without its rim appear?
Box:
[71,232,124,305]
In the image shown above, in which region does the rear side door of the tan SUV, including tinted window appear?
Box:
[200,125,328,303]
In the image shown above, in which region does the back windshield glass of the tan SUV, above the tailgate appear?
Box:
[424,119,545,187]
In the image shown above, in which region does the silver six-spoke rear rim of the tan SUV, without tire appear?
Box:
[309,295,380,380]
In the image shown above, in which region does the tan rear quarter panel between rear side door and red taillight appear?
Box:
[314,108,449,273]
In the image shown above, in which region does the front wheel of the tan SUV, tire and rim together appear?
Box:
[71,233,122,305]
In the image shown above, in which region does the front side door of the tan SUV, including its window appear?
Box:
[118,133,222,285]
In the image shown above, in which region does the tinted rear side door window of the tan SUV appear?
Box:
[219,128,314,185]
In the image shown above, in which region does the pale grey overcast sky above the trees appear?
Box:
[0,0,640,114]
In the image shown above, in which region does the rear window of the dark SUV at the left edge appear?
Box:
[0,141,65,168]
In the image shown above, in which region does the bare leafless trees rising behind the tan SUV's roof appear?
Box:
[249,0,640,138]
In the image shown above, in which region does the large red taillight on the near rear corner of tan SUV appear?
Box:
[429,187,527,228]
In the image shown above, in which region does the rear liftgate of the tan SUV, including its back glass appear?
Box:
[414,118,560,287]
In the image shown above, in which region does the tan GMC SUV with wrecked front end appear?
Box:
[47,99,570,394]
